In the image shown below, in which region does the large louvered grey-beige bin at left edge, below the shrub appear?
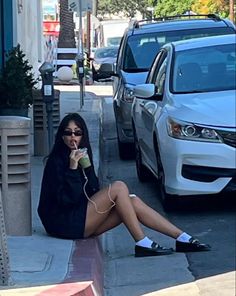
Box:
[0,116,32,236]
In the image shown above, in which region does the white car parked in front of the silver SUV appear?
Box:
[132,35,236,208]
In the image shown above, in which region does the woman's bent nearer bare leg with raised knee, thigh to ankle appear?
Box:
[84,181,145,241]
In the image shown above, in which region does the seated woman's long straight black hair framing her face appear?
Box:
[49,113,93,165]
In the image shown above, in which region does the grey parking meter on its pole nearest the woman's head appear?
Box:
[39,62,55,151]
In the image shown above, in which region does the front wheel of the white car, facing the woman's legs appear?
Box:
[156,147,176,212]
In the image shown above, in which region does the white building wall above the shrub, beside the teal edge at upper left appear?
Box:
[13,0,44,76]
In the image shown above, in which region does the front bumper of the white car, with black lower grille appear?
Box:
[160,137,236,195]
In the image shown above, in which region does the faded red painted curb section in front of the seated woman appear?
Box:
[37,238,104,296]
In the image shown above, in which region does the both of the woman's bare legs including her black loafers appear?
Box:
[84,182,211,252]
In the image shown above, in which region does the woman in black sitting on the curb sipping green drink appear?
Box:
[38,113,210,257]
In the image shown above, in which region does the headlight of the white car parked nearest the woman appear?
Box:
[167,117,222,142]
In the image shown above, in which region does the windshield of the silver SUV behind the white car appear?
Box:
[123,27,234,72]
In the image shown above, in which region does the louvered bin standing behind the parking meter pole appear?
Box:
[33,89,60,156]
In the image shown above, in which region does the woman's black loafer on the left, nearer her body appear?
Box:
[135,242,173,257]
